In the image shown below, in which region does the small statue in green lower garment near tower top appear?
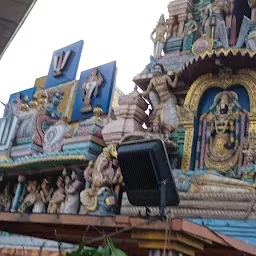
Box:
[182,13,197,51]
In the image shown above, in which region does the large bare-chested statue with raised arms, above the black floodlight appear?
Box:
[140,64,179,133]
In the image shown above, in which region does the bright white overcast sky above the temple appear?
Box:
[0,0,170,115]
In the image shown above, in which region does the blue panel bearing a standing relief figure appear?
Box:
[71,61,116,121]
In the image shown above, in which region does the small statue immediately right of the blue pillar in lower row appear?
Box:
[19,180,39,213]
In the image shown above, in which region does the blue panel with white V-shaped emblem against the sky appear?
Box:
[44,41,84,88]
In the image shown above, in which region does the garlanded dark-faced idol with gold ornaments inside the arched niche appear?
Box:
[196,91,248,174]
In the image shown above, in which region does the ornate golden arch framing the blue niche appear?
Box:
[181,69,256,170]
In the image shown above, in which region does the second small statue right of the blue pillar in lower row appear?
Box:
[32,178,53,213]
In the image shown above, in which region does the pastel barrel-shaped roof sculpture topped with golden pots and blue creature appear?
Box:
[12,88,64,158]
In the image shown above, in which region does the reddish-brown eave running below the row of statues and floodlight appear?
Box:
[0,213,256,256]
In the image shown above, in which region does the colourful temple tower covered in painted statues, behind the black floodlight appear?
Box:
[0,0,256,256]
